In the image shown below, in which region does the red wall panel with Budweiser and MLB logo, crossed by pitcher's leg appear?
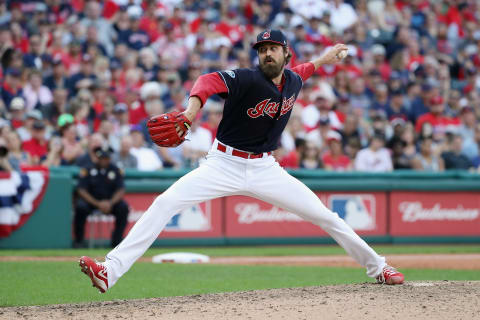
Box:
[225,192,387,237]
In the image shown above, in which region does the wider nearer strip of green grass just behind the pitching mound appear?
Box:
[0,262,480,307]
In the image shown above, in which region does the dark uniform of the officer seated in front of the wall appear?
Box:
[74,149,129,247]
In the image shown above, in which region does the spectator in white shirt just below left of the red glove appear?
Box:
[130,126,163,171]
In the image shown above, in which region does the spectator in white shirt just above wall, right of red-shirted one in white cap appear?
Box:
[354,134,393,172]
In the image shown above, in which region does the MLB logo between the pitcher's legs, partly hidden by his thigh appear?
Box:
[165,201,211,232]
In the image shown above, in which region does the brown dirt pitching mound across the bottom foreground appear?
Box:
[0,281,480,320]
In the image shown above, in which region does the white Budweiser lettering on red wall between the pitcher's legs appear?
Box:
[234,203,303,224]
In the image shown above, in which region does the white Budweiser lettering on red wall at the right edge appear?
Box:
[398,201,479,222]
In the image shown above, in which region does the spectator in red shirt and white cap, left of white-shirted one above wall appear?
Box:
[322,131,352,171]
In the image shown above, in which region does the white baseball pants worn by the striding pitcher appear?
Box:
[105,140,386,287]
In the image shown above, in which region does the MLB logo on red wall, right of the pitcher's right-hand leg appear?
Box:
[328,194,376,231]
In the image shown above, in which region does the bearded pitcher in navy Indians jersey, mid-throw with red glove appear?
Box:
[80,30,404,292]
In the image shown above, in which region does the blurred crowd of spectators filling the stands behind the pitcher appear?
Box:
[0,0,480,172]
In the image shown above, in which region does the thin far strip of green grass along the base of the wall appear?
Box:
[0,245,480,257]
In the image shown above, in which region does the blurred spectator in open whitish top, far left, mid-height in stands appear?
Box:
[23,70,53,110]
